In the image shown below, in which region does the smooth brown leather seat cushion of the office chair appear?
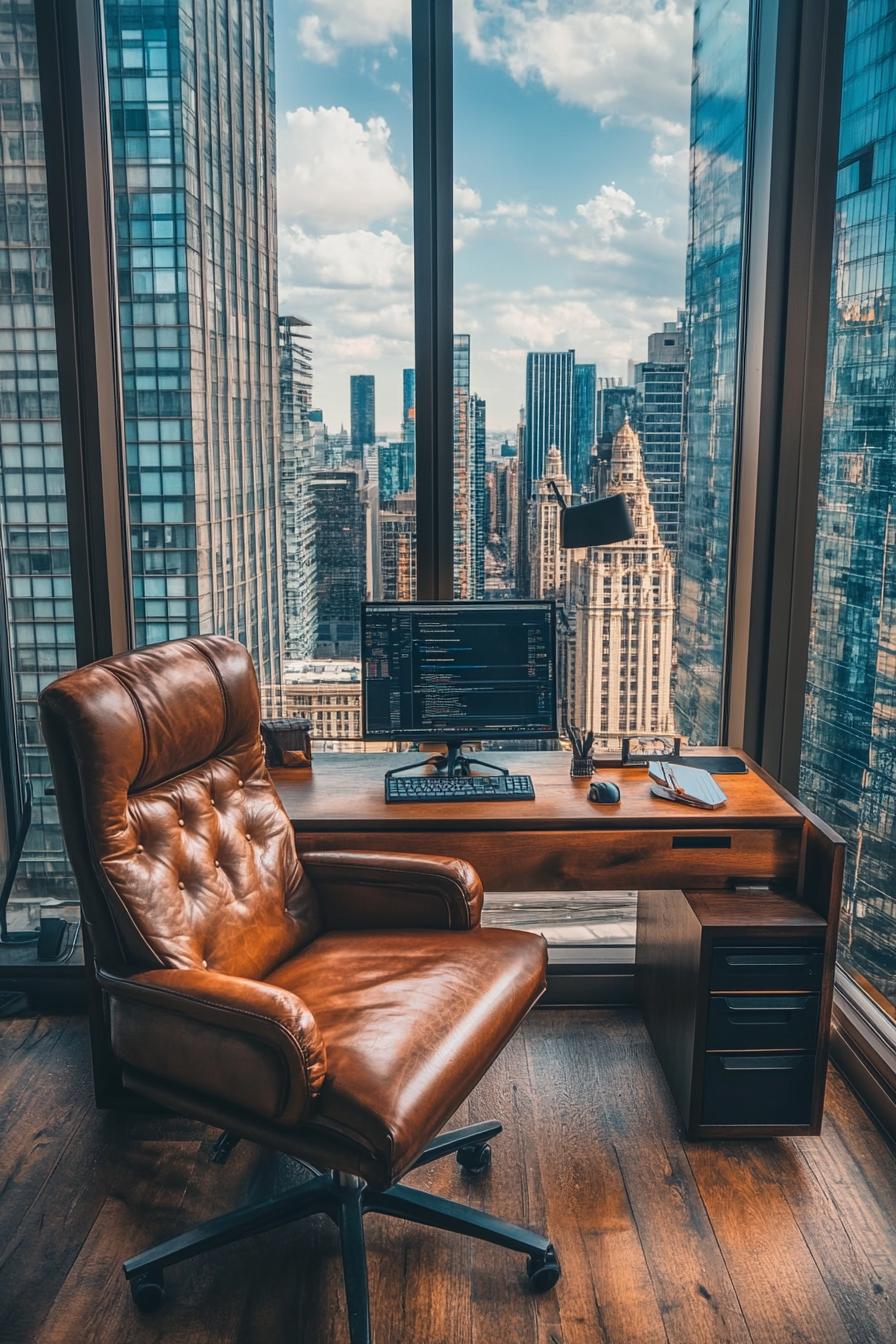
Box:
[267,929,547,1180]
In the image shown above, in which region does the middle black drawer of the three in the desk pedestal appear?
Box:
[707,995,819,1050]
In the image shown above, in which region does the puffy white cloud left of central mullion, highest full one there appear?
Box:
[277,108,411,230]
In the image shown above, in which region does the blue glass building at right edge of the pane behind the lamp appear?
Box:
[674,0,751,743]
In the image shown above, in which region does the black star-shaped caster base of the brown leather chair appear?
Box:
[124,1121,560,1344]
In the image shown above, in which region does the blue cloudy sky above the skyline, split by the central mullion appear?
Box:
[274,0,693,431]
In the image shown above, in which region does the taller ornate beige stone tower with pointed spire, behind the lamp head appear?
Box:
[568,415,674,750]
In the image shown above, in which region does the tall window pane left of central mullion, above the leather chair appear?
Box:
[105,0,416,750]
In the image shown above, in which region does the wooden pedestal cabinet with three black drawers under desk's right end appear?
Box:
[635,891,829,1138]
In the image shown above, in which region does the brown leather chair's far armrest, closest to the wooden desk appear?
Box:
[300,851,482,929]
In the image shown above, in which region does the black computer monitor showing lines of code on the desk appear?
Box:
[361,601,557,774]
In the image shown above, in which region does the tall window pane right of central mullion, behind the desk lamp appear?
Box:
[454,0,750,750]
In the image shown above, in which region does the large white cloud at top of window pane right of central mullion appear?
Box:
[454,0,693,140]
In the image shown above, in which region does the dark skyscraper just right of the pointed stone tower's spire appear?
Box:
[631,313,686,560]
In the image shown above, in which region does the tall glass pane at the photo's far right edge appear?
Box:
[801,0,896,1003]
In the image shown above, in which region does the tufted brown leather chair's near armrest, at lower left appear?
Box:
[98,970,326,1125]
